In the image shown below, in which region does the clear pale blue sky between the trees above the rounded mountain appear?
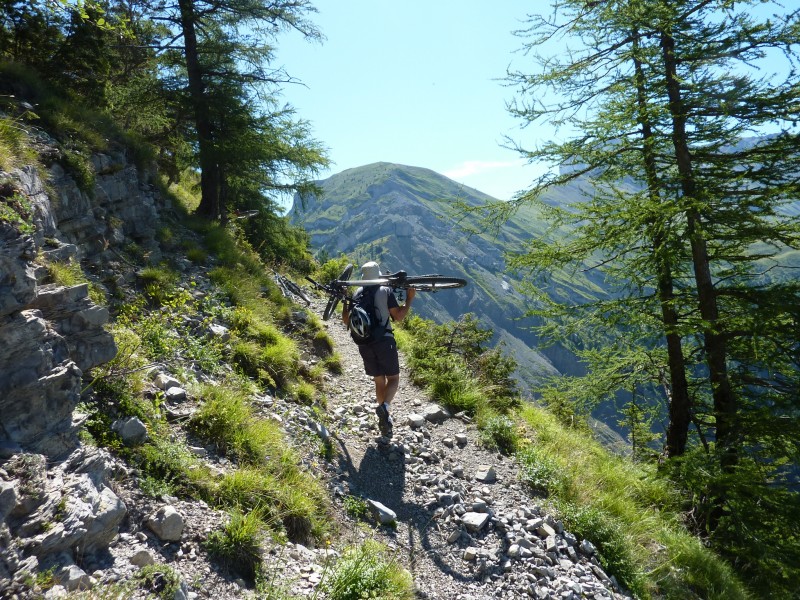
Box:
[277,0,551,205]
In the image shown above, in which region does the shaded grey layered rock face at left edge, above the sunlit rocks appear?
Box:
[0,146,155,458]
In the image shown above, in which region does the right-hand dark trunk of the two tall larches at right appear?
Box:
[661,32,738,471]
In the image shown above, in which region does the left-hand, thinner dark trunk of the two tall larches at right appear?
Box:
[632,42,691,456]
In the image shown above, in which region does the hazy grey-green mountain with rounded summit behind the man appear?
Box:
[292,162,602,389]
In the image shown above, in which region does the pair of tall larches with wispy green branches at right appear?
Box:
[506,0,800,589]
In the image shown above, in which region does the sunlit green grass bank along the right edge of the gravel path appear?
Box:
[519,405,748,600]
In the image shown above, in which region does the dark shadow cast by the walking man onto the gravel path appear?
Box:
[334,436,475,582]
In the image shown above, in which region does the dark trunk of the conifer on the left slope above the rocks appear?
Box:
[178,0,219,219]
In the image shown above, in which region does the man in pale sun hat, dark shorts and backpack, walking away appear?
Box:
[342,262,416,437]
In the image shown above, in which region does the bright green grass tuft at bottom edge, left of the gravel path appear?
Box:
[320,540,414,600]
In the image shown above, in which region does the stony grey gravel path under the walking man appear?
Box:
[310,298,625,600]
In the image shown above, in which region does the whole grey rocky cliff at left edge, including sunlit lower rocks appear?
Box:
[0,141,159,598]
